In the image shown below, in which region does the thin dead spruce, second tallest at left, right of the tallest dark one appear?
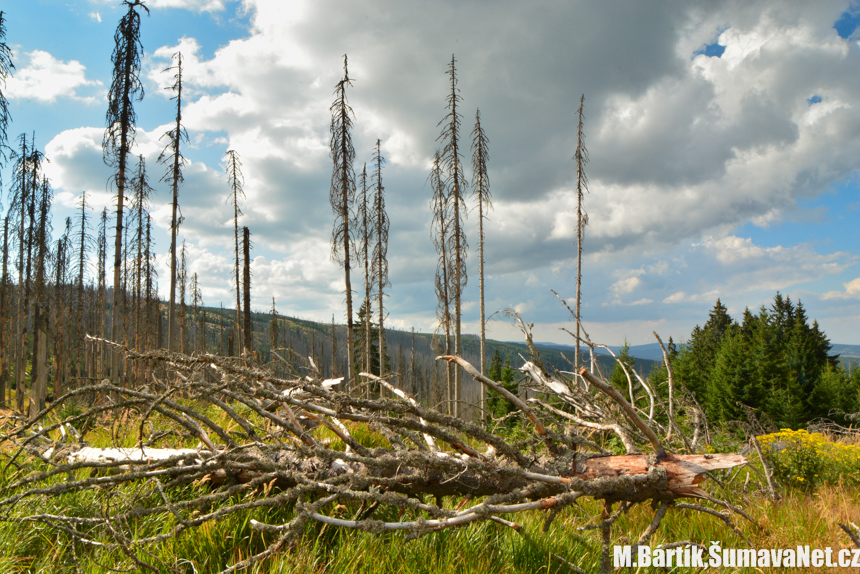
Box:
[158,52,188,351]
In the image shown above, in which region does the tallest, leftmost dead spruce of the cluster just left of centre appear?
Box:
[329,54,356,396]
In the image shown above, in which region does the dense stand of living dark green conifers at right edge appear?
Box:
[673,293,860,429]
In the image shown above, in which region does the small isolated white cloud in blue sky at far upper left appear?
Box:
[4,50,102,103]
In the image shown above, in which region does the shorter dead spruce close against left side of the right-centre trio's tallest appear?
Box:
[429,150,454,415]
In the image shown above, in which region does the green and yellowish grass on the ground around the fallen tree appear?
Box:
[0,398,860,574]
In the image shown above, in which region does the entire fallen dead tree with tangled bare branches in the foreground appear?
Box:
[0,335,746,572]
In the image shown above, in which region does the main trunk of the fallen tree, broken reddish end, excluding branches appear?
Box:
[63,447,747,502]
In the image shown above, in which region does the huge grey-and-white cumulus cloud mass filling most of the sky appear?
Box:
[28,0,860,346]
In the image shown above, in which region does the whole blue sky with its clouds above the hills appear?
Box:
[0,0,860,345]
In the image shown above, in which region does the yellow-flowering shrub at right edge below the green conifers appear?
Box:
[758,429,860,490]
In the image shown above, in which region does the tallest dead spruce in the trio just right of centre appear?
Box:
[436,54,469,416]
